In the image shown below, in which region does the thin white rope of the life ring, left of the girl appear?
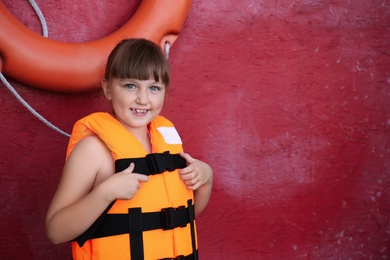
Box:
[0,0,70,137]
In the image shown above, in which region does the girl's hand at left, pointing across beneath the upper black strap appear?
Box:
[102,163,149,201]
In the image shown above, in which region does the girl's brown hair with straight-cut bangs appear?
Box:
[105,39,170,87]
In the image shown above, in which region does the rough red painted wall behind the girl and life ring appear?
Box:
[0,0,390,259]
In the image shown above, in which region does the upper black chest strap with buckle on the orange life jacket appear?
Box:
[115,151,187,175]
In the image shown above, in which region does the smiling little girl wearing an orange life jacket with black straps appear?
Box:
[46,39,213,260]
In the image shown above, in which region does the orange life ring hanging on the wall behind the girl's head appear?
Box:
[0,0,192,92]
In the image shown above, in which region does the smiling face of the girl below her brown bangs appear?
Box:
[102,77,165,132]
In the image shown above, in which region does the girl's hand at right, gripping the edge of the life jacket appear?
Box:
[179,152,213,191]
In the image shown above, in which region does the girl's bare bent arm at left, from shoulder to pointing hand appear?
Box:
[46,136,147,244]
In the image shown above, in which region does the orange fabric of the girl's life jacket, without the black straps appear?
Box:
[66,113,197,260]
